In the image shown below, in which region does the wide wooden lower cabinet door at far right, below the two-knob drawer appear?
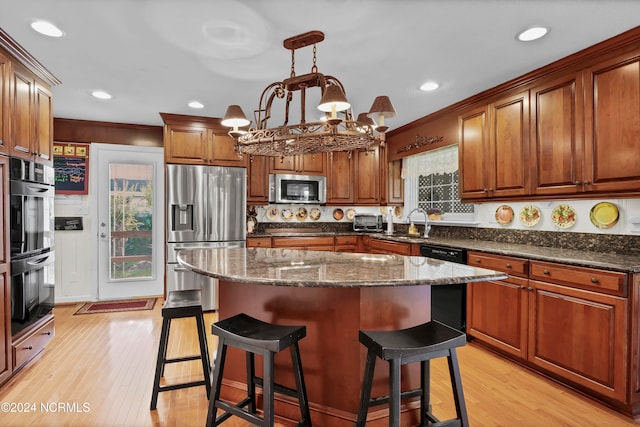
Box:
[528,280,628,401]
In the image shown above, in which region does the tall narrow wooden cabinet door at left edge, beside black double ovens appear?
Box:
[0,156,13,384]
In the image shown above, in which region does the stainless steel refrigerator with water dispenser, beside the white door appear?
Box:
[166,165,247,311]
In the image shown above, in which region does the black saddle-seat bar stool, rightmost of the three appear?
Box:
[356,321,469,427]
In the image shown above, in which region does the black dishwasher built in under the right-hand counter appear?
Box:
[420,244,467,332]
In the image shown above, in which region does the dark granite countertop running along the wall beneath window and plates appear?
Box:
[252,231,640,273]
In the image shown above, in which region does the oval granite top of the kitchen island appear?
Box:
[178,248,507,288]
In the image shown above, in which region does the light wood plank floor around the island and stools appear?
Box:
[0,300,638,427]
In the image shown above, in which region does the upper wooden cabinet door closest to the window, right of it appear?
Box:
[458,106,491,200]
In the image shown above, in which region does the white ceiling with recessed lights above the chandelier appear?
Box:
[0,0,640,129]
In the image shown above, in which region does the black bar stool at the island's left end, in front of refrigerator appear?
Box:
[151,289,211,409]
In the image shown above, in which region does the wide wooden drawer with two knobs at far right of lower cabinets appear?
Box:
[530,261,627,297]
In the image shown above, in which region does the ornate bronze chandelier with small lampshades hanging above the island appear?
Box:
[221,31,396,157]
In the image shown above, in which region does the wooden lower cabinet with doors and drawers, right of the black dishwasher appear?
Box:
[467,251,638,412]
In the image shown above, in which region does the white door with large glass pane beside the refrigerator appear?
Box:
[90,144,164,300]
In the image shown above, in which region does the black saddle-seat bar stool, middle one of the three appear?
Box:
[206,313,311,427]
